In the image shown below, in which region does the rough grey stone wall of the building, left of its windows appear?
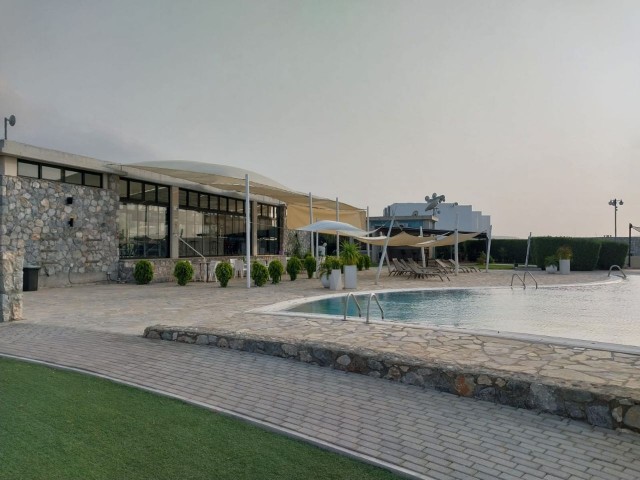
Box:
[0,175,119,275]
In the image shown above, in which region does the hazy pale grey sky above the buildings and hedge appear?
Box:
[0,0,640,238]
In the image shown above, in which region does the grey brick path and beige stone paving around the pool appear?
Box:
[0,271,640,479]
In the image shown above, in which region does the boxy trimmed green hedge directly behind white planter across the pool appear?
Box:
[528,237,608,272]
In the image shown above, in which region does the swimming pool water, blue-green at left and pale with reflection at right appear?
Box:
[288,276,640,347]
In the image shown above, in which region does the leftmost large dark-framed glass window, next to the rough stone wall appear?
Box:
[118,179,169,258]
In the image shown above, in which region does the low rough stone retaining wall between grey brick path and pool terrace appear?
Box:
[144,325,640,432]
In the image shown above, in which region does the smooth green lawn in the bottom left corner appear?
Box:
[0,358,396,480]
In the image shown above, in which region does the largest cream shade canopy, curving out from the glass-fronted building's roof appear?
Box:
[129,161,366,229]
